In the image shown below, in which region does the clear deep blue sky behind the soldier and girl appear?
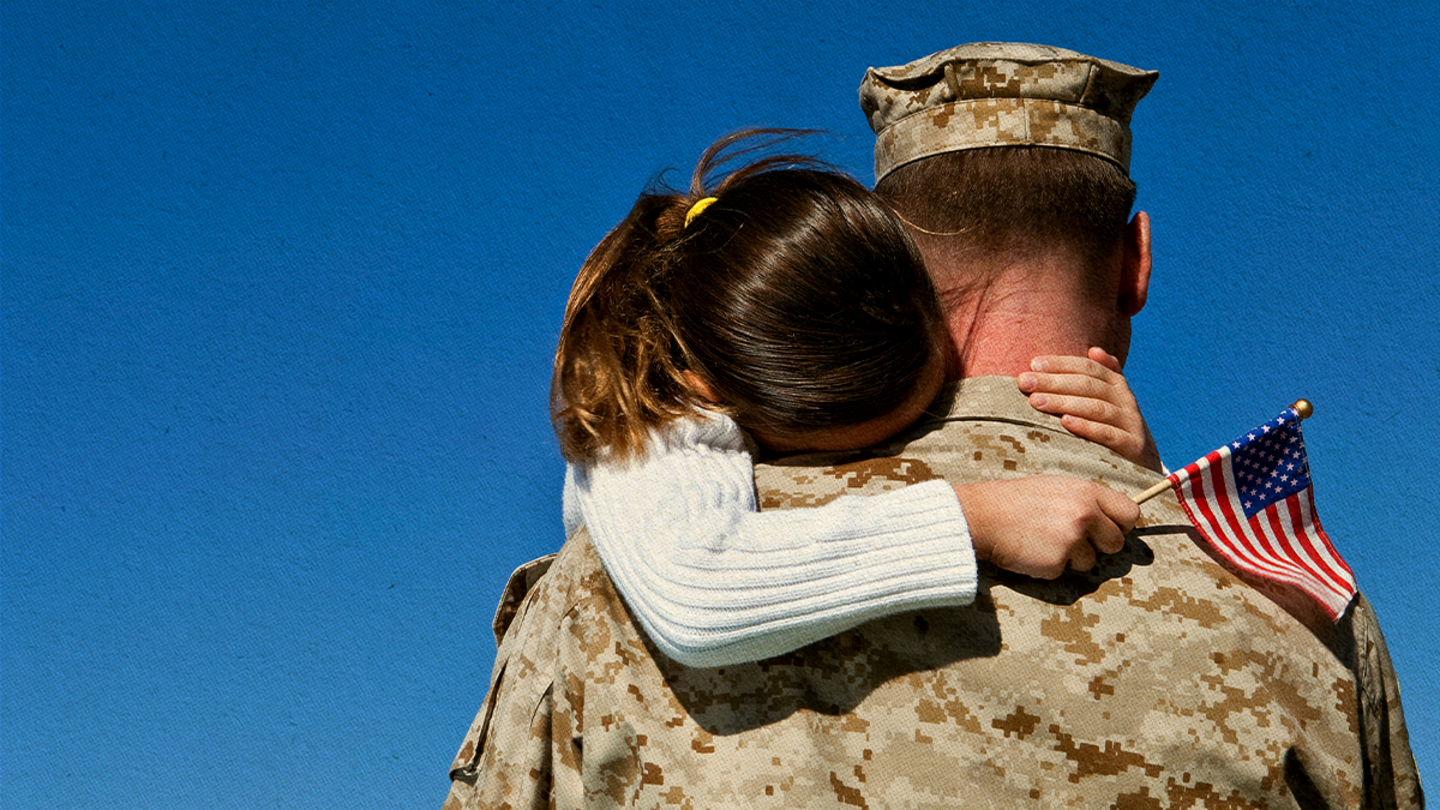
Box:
[0,0,1440,809]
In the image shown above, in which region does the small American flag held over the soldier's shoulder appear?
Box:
[1168,408,1356,620]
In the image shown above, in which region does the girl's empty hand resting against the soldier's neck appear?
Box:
[1017,347,1162,473]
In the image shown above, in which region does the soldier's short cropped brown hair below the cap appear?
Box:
[876,147,1135,264]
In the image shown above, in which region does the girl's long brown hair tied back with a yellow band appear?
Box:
[550,130,942,461]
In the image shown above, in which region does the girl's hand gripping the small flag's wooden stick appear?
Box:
[955,476,1140,579]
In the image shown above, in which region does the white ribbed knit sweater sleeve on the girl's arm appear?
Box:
[564,415,976,667]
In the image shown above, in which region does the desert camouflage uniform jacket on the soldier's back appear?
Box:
[444,378,1423,810]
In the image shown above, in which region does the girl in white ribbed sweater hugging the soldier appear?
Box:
[552,133,1143,666]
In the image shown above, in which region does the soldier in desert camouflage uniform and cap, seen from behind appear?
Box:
[445,43,1423,810]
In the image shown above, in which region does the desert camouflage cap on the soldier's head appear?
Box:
[860,42,1159,180]
